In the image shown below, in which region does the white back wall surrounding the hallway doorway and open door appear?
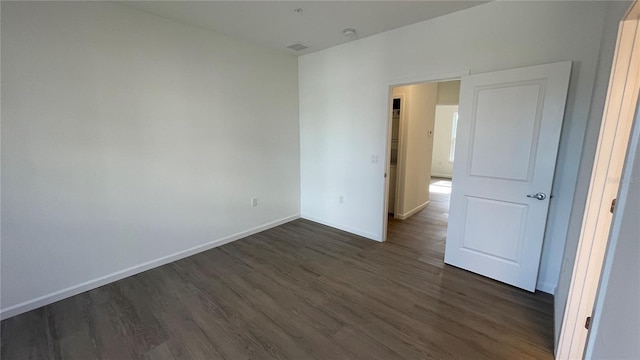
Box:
[299,1,607,292]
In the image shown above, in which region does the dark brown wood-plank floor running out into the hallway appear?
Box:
[1,180,553,360]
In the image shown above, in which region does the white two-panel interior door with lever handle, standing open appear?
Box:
[445,61,571,291]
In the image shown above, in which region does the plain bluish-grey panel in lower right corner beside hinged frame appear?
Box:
[585,99,640,359]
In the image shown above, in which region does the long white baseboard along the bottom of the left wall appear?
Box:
[0,214,300,320]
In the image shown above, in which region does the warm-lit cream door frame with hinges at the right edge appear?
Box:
[556,1,640,359]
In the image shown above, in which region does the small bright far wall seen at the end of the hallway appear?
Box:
[431,105,458,178]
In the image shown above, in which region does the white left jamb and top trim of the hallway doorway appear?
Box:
[381,70,471,241]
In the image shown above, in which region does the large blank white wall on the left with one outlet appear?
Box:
[1,2,300,317]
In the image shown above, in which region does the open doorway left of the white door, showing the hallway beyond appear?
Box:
[386,80,460,256]
